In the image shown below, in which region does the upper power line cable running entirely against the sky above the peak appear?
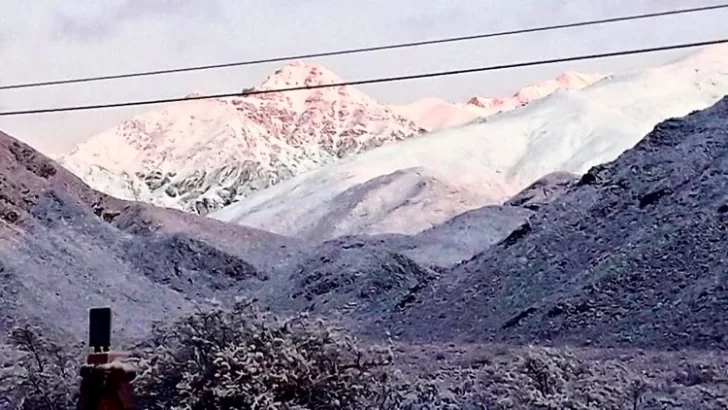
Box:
[0,4,728,90]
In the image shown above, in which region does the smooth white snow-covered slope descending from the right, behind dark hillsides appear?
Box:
[212,45,728,237]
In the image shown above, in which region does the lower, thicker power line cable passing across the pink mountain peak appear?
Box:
[0,39,728,117]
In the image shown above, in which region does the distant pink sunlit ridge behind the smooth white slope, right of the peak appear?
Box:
[392,71,605,131]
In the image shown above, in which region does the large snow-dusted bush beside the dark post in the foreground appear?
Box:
[136,302,472,410]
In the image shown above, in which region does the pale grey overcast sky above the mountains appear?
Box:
[0,0,728,153]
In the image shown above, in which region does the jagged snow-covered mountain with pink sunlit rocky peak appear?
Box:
[58,62,425,214]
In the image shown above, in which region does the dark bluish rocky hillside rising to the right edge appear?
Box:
[396,98,728,349]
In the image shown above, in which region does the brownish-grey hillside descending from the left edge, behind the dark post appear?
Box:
[0,133,297,339]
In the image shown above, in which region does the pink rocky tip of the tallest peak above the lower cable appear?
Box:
[257,61,344,90]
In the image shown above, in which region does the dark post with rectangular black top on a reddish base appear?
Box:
[76,307,136,410]
